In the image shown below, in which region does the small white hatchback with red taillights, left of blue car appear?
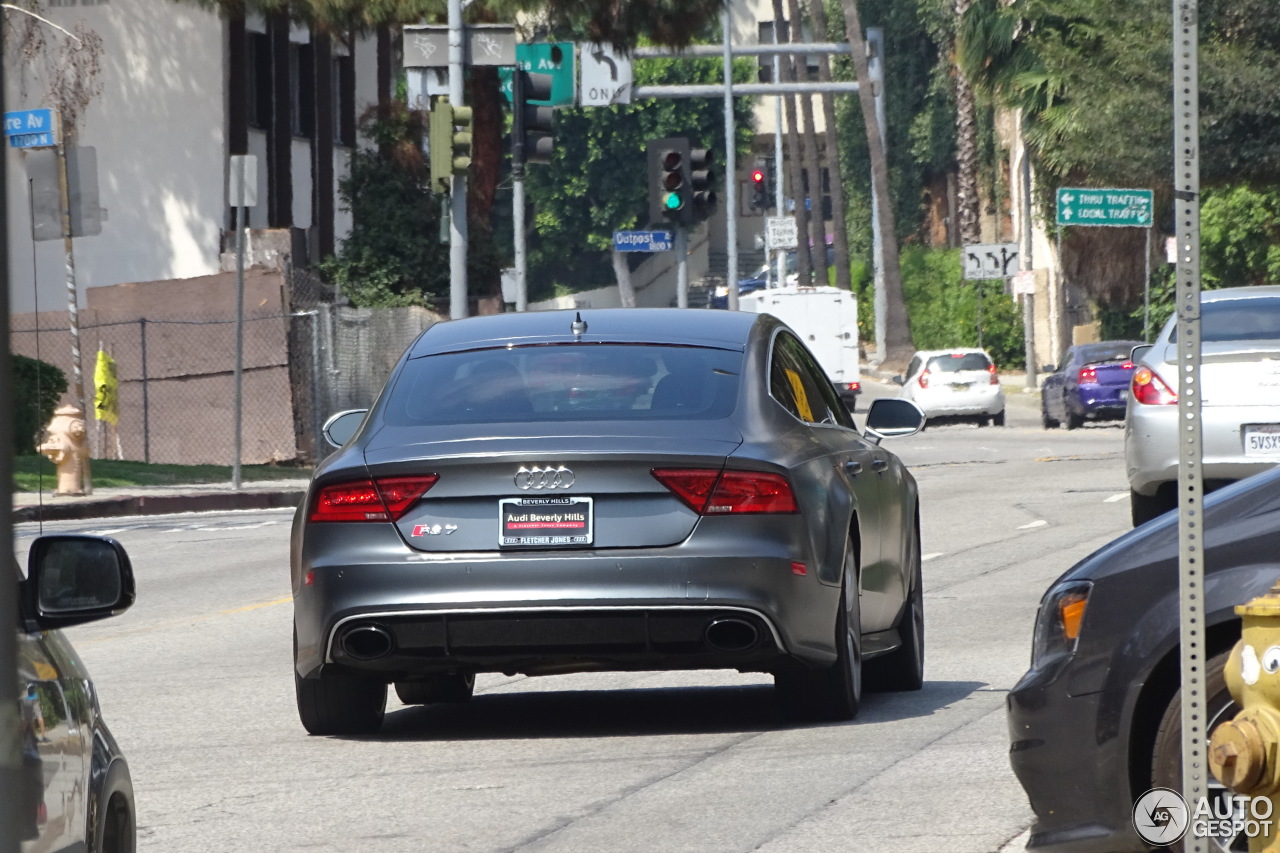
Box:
[893,347,1005,427]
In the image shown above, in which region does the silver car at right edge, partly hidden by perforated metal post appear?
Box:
[1124,286,1280,526]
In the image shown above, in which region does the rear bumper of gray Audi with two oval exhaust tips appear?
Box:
[294,525,840,676]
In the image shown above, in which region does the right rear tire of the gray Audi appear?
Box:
[773,540,863,722]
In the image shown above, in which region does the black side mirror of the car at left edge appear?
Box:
[23,534,134,630]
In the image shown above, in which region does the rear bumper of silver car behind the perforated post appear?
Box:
[1124,403,1280,496]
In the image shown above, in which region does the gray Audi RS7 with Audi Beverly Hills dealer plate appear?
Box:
[292,309,924,734]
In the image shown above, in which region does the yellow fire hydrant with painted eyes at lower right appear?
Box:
[1208,581,1280,853]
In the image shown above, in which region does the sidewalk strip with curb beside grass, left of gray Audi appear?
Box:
[13,479,307,524]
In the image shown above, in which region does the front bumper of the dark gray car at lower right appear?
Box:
[1007,660,1147,853]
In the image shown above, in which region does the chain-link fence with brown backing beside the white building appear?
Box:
[10,270,439,465]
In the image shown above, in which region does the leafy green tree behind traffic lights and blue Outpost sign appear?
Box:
[526,49,754,298]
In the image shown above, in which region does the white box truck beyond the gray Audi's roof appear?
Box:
[739,284,861,411]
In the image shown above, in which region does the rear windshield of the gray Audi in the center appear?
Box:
[383,343,742,427]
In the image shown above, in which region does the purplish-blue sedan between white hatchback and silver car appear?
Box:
[1041,341,1144,429]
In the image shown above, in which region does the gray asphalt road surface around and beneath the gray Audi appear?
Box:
[18,386,1129,853]
